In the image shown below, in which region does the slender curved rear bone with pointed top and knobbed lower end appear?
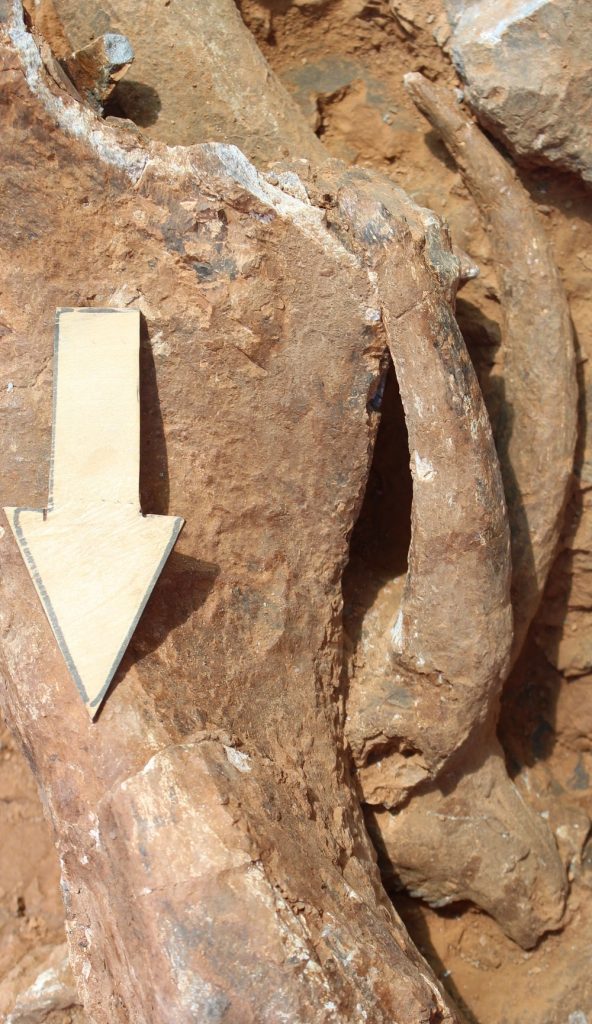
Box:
[348,74,577,947]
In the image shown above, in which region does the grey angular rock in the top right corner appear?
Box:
[446,0,592,182]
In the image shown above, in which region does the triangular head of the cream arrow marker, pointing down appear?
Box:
[4,503,183,720]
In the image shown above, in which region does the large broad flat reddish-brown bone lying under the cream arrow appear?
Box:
[0,4,456,1024]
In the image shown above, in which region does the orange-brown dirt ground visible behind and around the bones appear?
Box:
[0,0,592,1024]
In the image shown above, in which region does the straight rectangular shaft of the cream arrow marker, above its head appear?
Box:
[49,309,139,508]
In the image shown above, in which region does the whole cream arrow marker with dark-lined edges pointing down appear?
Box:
[4,309,183,718]
